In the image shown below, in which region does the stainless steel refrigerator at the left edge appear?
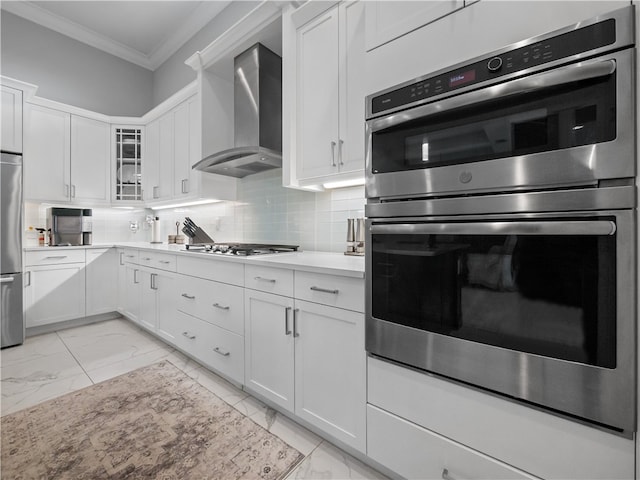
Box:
[0,152,24,348]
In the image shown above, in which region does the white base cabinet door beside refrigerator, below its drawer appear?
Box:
[24,263,85,328]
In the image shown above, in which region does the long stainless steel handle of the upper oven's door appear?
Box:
[367,60,616,132]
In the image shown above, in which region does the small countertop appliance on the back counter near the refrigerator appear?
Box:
[47,207,93,247]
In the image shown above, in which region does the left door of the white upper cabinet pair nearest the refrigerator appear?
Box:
[24,104,71,202]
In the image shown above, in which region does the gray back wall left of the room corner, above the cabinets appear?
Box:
[0,11,153,116]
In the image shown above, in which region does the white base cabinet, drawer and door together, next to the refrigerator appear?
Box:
[24,250,85,328]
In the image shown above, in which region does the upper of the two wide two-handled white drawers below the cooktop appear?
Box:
[178,275,244,335]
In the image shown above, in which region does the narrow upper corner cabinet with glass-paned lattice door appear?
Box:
[113,126,142,202]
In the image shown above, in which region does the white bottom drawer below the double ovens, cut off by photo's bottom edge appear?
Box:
[367,405,535,480]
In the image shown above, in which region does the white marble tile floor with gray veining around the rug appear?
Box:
[0,319,386,480]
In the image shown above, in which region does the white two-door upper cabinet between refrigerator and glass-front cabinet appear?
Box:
[24,104,110,204]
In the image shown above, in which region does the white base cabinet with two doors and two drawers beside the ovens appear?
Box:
[245,265,366,452]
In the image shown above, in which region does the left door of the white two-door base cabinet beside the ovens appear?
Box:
[245,290,294,412]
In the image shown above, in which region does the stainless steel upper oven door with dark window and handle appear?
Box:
[366,49,635,202]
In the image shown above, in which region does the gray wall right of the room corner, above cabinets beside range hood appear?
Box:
[153,1,260,106]
